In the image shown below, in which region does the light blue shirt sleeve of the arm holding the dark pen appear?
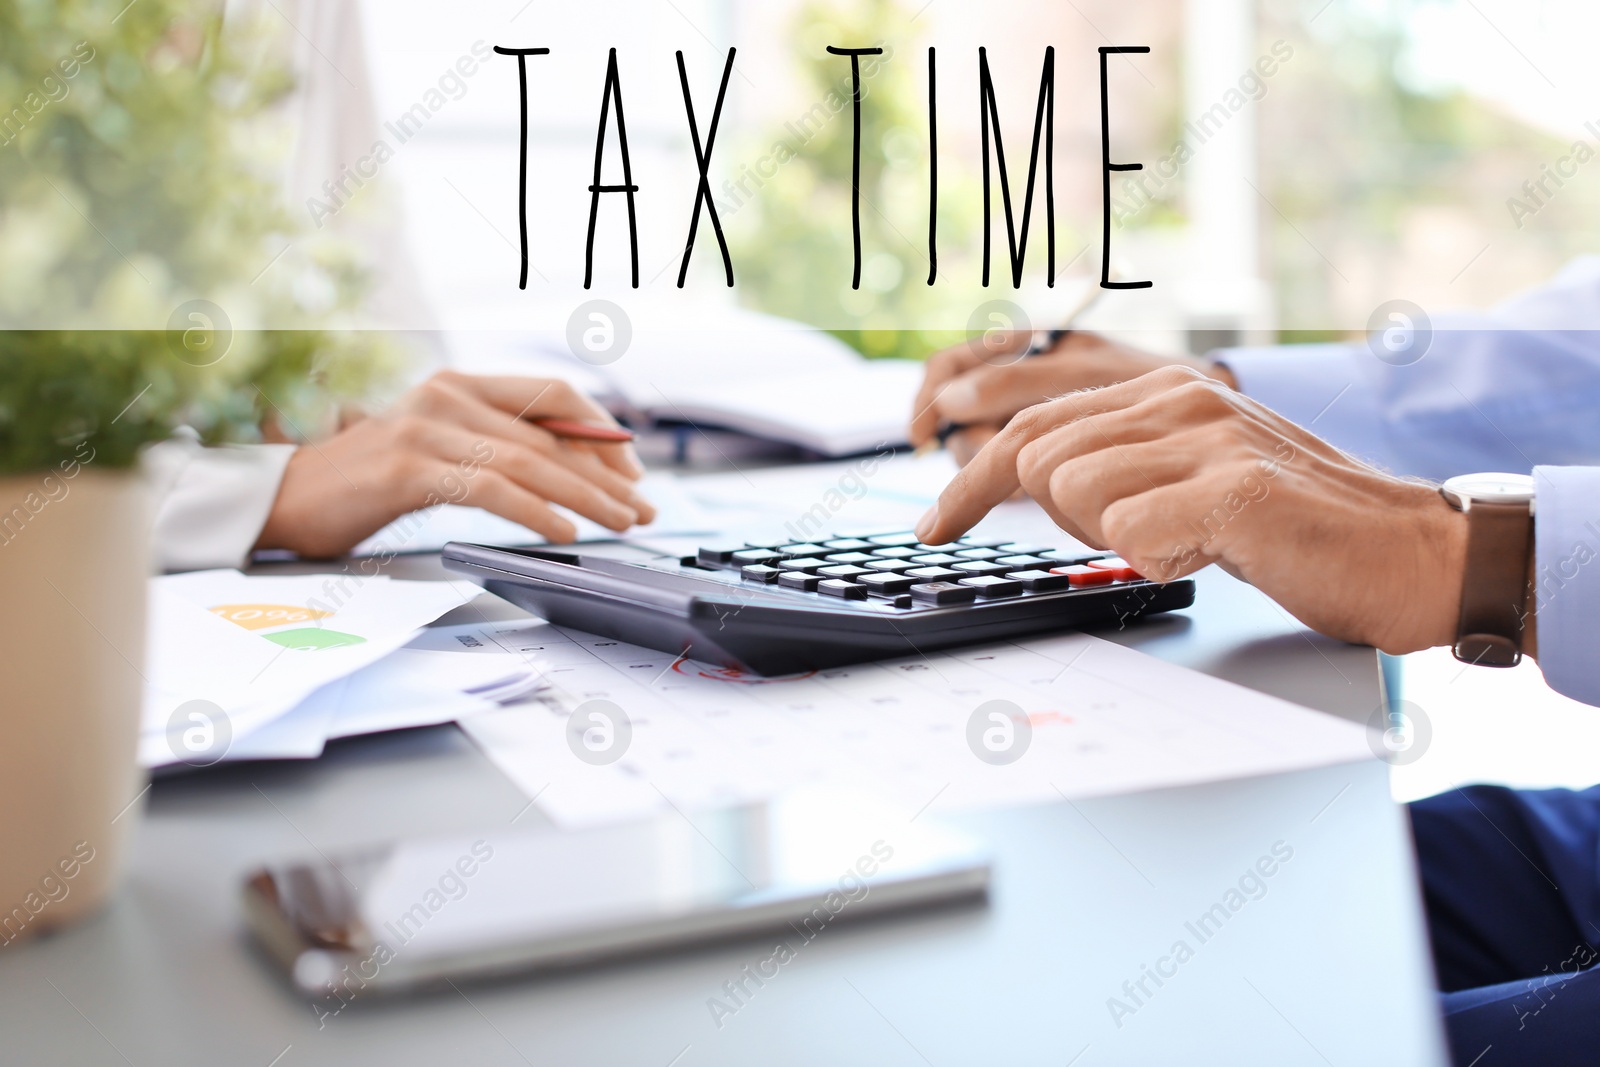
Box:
[1214,258,1600,480]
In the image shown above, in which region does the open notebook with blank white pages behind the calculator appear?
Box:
[451,312,922,456]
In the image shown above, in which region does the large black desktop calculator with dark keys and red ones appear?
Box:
[443,531,1195,675]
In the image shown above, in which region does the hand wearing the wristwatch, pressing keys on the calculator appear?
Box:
[917,368,1467,654]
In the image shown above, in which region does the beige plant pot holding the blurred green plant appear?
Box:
[0,462,150,940]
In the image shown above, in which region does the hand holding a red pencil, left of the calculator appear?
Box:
[256,371,656,558]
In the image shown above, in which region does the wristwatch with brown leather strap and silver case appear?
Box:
[1438,474,1533,667]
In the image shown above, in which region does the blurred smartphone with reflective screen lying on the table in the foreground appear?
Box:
[245,790,990,1003]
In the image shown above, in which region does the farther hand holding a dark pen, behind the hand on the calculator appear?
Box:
[910,331,1235,464]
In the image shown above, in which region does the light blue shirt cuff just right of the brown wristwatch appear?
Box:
[1533,467,1600,707]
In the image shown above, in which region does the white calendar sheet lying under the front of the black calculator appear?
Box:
[461,622,1373,827]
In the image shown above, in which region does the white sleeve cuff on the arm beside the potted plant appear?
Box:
[144,432,294,571]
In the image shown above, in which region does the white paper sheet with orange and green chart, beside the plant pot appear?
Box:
[139,571,482,766]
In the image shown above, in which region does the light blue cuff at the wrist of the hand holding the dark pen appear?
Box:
[1211,344,1400,470]
